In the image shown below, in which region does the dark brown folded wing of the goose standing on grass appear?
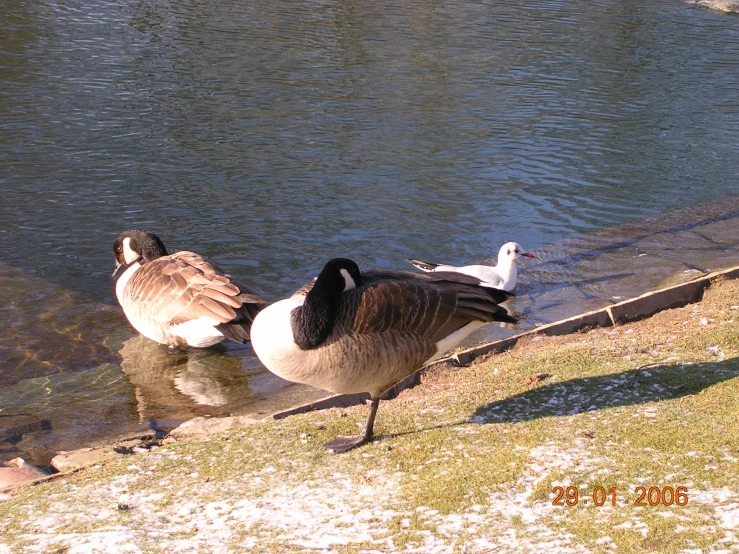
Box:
[337,271,515,342]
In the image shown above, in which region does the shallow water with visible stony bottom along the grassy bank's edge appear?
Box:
[0,197,739,469]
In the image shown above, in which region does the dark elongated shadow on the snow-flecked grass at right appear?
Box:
[470,358,739,423]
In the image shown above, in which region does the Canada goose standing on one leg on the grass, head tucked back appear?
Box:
[251,258,516,452]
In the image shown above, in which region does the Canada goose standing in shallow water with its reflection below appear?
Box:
[113,231,267,347]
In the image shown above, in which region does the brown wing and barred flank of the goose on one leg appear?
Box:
[284,270,516,397]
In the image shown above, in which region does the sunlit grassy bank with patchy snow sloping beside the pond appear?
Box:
[0,281,739,554]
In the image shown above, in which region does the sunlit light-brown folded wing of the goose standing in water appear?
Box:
[126,252,266,325]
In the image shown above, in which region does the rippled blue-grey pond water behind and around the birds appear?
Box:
[0,0,739,466]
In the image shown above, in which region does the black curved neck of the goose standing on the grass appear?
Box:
[290,266,344,350]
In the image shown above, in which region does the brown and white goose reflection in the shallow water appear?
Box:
[120,335,251,421]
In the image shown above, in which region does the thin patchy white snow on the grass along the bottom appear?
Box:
[5,439,739,554]
